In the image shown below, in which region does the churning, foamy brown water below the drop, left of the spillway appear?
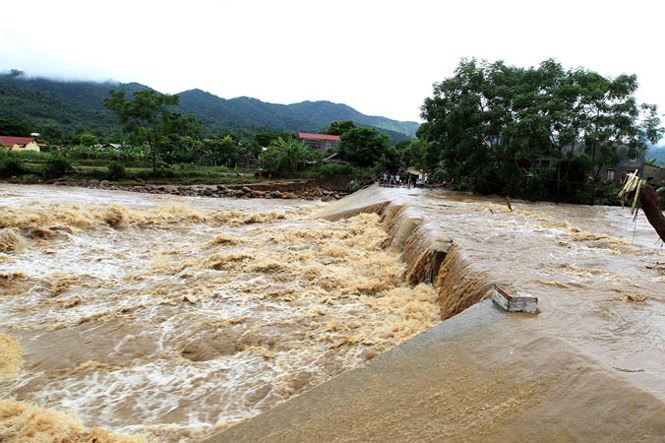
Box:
[0,185,439,440]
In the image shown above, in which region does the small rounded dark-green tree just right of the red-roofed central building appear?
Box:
[339,128,388,167]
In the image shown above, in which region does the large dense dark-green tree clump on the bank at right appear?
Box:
[419,59,663,202]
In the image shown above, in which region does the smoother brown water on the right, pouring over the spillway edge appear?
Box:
[325,189,665,401]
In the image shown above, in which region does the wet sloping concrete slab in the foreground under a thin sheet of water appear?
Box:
[206,301,665,443]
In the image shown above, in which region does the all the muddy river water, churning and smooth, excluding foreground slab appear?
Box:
[0,184,665,440]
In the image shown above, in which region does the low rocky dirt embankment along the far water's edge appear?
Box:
[50,180,348,201]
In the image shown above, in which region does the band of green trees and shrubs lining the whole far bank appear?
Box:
[0,59,664,204]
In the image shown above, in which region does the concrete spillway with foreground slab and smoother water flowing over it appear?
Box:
[208,187,665,442]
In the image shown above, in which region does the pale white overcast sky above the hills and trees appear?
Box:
[0,0,665,124]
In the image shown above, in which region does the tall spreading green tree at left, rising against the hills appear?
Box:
[104,89,202,171]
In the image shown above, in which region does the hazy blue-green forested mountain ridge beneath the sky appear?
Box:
[0,72,418,139]
